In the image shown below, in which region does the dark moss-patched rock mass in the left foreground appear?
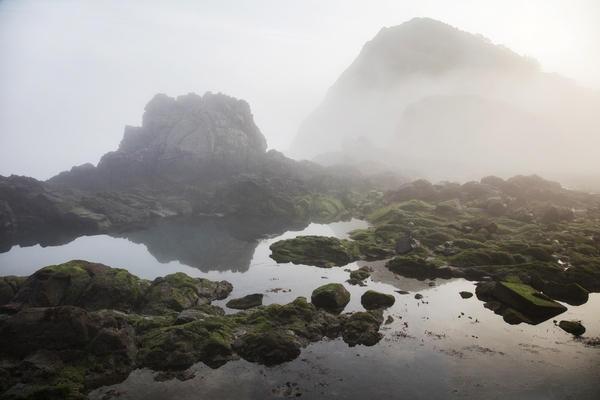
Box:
[0,261,383,398]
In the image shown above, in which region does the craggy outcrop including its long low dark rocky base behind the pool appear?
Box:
[0,93,403,251]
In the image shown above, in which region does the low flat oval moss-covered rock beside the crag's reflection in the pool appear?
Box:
[269,236,360,268]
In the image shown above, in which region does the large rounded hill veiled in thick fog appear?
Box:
[290,18,600,180]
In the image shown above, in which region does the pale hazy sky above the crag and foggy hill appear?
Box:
[0,0,600,179]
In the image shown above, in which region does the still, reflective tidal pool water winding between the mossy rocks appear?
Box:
[0,219,600,400]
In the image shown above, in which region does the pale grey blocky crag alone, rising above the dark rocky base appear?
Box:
[48,92,267,191]
